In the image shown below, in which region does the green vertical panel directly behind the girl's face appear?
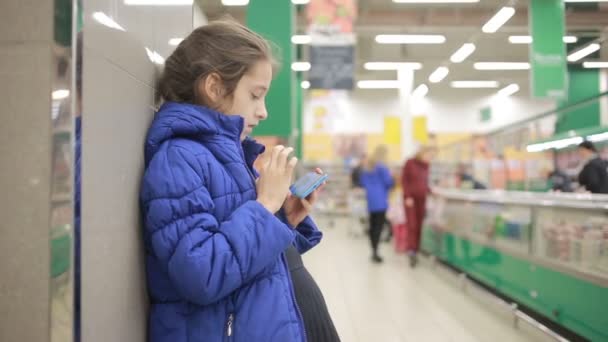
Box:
[247,0,296,138]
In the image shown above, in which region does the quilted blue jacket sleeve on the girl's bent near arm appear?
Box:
[141,147,295,305]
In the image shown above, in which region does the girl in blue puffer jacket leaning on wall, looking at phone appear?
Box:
[141,21,334,342]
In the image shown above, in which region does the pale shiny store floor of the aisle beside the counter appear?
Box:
[304,219,552,342]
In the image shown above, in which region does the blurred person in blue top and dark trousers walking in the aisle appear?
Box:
[359,145,395,263]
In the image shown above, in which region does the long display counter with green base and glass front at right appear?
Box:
[422,189,608,341]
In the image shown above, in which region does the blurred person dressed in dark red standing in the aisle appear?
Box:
[401,146,435,267]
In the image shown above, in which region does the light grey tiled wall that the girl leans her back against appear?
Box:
[82,0,197,342]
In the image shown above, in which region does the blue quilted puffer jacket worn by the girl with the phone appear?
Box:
[141,103,321,342]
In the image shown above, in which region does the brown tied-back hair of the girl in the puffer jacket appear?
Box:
[157,19,277,108]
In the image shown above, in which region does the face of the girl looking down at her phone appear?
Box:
[223,60,272,140]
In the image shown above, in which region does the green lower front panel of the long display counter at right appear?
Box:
[422,228,608,341]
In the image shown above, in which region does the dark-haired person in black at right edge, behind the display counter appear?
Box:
[578,141,608,194]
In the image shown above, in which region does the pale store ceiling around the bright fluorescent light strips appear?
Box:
[197,0,608,97]
